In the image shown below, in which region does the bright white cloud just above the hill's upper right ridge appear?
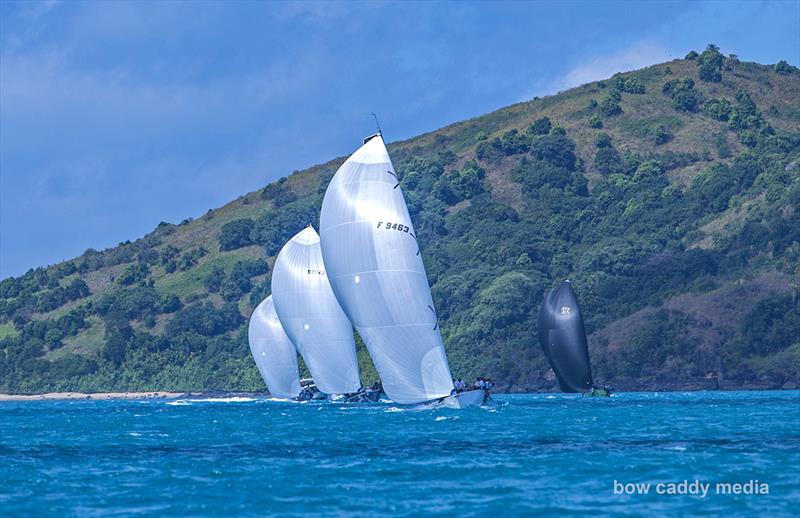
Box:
[551,40,673,93]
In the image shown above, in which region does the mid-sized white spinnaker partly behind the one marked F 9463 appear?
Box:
[272,226,361,394]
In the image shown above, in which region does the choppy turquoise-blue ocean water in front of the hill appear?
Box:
[0,391,800,516]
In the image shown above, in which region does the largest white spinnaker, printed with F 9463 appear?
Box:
[320,135,453,404]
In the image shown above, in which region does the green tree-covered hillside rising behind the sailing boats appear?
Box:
[0,46,800,392]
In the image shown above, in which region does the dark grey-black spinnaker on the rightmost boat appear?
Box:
[539,280,593,392]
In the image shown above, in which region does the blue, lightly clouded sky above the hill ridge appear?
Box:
[0,0,800,278]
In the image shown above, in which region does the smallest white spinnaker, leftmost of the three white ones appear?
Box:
[247,295,300,398]
